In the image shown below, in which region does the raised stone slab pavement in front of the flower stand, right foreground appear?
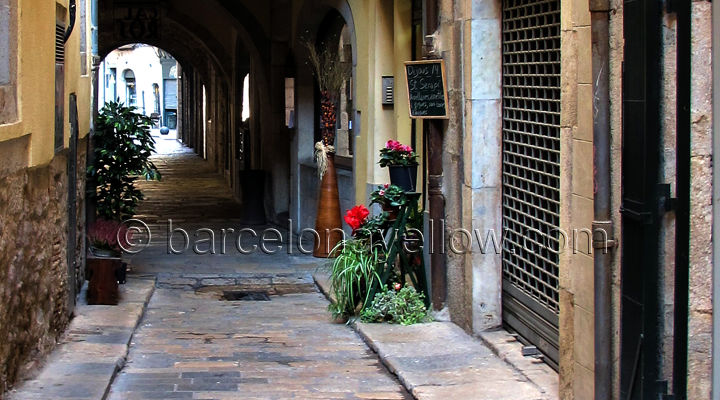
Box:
[355,322,553,400]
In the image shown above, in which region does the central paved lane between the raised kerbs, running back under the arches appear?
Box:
[109,137,408,400]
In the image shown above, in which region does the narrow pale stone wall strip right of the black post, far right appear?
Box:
[687,0,713,400]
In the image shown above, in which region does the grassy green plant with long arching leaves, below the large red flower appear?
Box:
[328,238,383,318]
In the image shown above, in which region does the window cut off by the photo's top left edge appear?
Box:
[0,0,17,124]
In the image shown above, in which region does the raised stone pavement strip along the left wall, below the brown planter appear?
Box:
[5,275,155,400]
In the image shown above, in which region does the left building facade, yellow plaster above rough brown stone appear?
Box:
[0,0,92,389]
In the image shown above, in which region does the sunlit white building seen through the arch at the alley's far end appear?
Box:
[98,44,179,129]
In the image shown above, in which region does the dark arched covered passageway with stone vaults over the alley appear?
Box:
[98,0,360,238]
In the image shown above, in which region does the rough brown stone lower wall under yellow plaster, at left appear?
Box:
[0,136,86,393]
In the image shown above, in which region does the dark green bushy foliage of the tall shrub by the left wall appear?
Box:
[88,101,161,220]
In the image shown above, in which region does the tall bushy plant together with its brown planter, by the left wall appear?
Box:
[87,102,160,304]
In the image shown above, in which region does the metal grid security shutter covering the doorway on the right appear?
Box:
[502,0,561,363]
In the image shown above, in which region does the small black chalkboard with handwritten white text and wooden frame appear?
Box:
[405,60,448,118]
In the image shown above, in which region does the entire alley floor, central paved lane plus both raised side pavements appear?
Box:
[4,139,556,400]
